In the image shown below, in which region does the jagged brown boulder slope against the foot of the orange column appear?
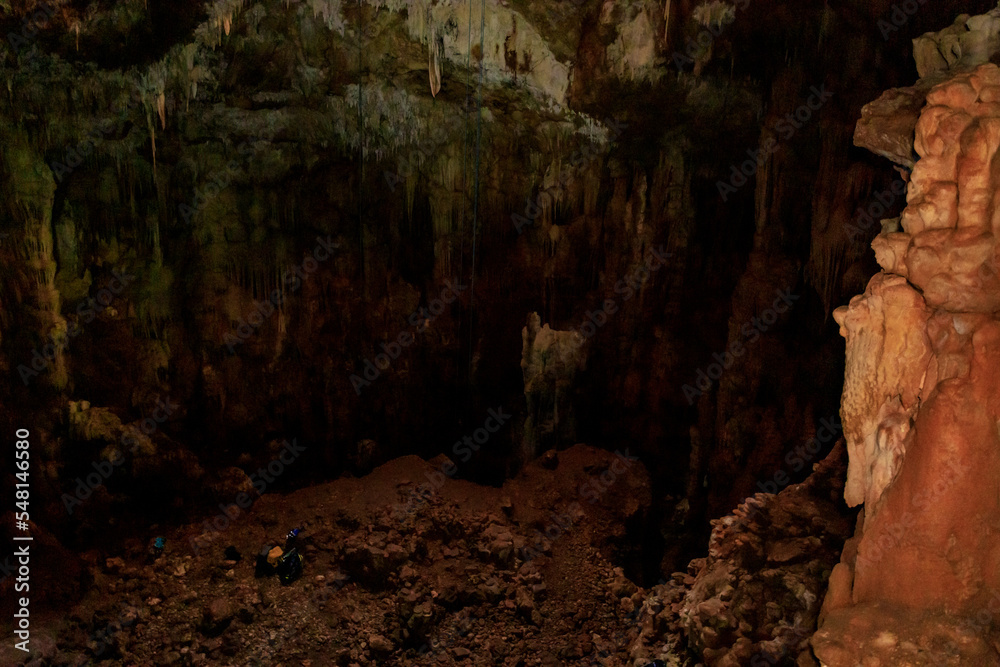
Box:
[632,445,853,667]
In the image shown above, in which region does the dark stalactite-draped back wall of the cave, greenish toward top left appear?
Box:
[0,0,992,556]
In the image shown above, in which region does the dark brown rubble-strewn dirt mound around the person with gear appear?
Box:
[0,445,668,667]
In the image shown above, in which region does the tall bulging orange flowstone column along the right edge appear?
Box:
[813,6,1000,667]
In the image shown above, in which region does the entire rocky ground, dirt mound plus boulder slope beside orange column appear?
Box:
[0,438,852,667]
